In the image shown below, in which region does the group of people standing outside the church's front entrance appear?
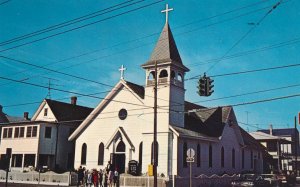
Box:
[77,161,119,187]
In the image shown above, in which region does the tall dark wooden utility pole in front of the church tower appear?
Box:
[153,61,158,187]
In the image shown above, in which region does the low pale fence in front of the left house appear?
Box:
[0,170,77,186]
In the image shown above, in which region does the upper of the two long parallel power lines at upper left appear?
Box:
[0,0,145,46]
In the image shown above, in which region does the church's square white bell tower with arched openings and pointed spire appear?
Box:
[141,17,189,131]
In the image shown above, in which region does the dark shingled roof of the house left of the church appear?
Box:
[46,99,93,122]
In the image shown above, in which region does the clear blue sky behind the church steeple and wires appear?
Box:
[0,0,300,131]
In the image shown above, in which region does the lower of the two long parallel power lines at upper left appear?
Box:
[0,0,164,52]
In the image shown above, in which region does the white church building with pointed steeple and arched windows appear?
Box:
[69,8,264,176]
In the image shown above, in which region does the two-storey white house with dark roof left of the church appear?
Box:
[0,97,92,170]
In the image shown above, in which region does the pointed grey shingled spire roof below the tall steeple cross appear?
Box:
[142,23,189,71]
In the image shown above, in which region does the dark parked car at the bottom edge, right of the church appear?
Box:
[231,174,270,187]
